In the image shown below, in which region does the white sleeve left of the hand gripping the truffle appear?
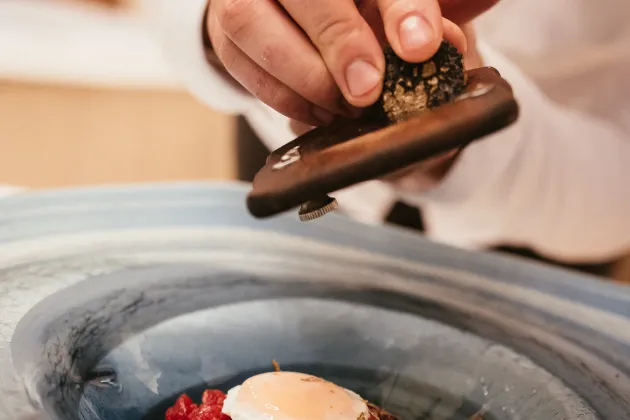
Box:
[138,0,255,114]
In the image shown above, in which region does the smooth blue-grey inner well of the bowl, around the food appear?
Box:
[94,298,596,420]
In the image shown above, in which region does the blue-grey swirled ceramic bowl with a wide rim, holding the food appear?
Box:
[0,184,630,420]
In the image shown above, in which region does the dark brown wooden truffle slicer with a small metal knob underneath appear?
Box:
[247,67,518,221]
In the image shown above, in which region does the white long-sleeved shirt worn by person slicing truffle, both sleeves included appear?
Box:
[135,0,630,262]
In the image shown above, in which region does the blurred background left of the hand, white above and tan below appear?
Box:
[0,0,237,188]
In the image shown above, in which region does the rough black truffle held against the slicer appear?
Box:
[375,40,466,122]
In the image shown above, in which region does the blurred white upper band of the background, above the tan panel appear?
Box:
[0,0,179,88]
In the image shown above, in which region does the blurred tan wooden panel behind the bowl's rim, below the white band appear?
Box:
[0,81,236,188]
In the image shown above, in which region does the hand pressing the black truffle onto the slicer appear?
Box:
[207,0,470,126]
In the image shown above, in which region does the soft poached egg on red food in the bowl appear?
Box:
[223,372,369,420]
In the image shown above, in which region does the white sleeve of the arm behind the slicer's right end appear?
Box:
[398,39,630,262]
